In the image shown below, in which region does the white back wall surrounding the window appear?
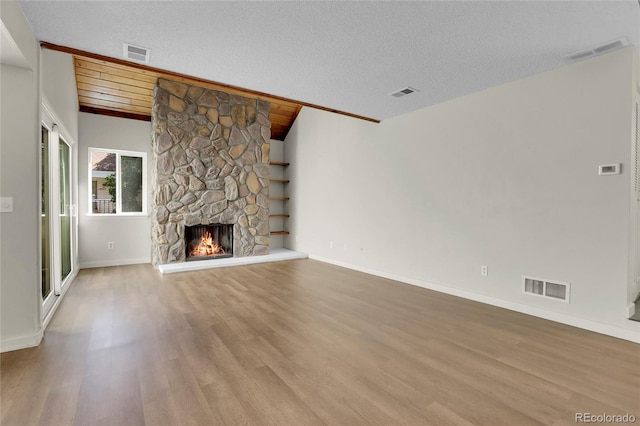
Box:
[78,113,151,268]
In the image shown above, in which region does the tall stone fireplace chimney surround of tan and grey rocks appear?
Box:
[151,79,270,266]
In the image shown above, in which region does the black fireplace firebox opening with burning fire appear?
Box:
[184,224,233,262]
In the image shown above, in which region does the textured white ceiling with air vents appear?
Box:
[15,0,640,119]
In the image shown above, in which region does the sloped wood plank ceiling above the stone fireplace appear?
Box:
[73,55,302,140]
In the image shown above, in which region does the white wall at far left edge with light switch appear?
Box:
[0,1,42,352]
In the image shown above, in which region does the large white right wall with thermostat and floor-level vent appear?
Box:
[285,48,640,340]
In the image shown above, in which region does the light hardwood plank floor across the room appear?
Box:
[0,260,640,426]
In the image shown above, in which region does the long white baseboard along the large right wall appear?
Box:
[309,254,640,343]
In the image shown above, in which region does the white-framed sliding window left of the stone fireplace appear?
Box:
[89,148,147,215]
